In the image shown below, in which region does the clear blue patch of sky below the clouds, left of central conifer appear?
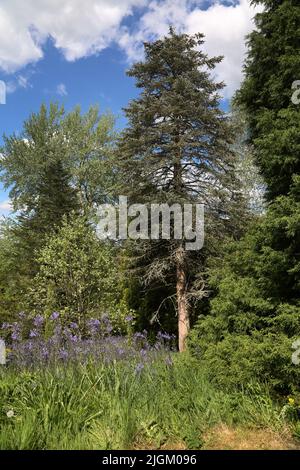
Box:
[0,40,137,138]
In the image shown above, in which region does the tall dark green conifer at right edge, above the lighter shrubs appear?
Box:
[237,0,300,303]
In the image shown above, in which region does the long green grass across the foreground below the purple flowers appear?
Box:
[0,355,296,449]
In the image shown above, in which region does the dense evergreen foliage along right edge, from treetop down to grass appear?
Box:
[190,0,300,393]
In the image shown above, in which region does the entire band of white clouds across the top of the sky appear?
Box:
[0,0,262,96]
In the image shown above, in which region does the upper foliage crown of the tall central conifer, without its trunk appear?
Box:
[119,29,244,220]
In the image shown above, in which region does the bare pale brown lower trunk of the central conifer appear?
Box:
[176,247,190,352]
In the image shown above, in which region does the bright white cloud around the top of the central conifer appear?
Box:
[119,0,261,97]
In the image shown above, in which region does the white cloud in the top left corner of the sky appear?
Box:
[0,0,145,73]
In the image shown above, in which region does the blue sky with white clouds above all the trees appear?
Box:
[0,0,255,215]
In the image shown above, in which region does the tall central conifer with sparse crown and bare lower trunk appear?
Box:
[119,28,245,351]
